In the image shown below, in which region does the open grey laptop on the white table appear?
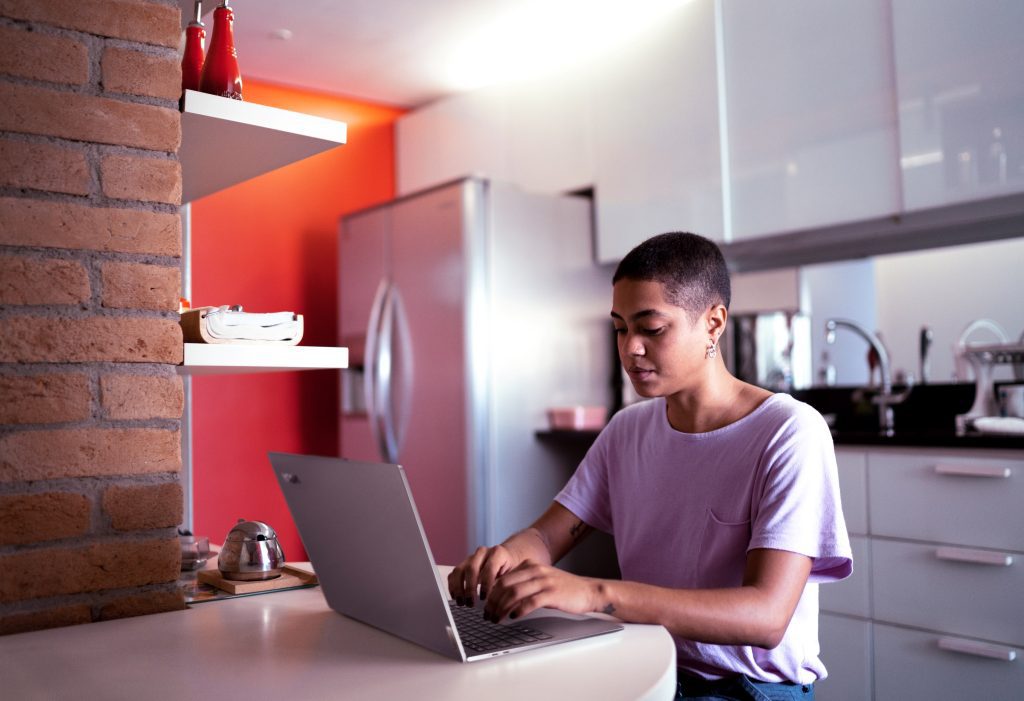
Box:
[269,452,623,662]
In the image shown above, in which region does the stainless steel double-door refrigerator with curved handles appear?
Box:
[339,178,612,563]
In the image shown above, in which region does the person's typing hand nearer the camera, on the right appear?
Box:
[483,560,602,623]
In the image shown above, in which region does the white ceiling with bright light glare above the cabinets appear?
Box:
[179,0,686,107]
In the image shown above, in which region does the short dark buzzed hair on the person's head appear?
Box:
[611,231,732,318]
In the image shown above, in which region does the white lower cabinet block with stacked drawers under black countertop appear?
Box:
[815,447,1024,701]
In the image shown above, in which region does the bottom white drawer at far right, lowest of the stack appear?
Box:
[872,623,1024,701]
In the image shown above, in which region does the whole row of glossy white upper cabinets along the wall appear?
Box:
[397,0,1024,262]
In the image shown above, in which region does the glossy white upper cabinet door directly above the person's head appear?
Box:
[593,0,723,262]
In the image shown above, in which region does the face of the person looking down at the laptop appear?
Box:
[611,278,712,397]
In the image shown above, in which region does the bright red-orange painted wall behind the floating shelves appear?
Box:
[191,81,403,560]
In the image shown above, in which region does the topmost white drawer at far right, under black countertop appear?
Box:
[867,451,1024,552]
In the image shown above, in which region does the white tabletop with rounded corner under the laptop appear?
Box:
[0,564,676,701]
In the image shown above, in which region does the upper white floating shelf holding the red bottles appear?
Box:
[178,90,348,203]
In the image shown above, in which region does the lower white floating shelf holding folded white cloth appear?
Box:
[178,343,348,375]
